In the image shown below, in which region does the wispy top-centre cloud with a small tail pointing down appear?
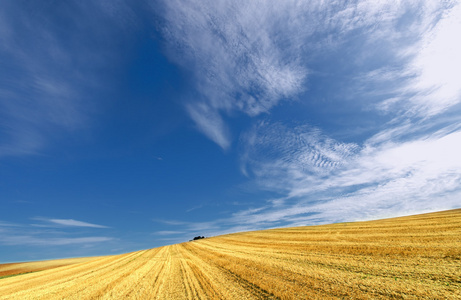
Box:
[156,1,308,148]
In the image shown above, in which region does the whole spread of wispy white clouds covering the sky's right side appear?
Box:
[152,1,461,232]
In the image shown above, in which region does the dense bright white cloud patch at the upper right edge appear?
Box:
[365,2,461,118]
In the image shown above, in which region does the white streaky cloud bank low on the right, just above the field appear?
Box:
[234,125,461,225]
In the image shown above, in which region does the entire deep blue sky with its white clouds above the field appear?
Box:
[0,0,461,263]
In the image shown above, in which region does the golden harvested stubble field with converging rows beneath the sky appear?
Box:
[0,209,461,299]
